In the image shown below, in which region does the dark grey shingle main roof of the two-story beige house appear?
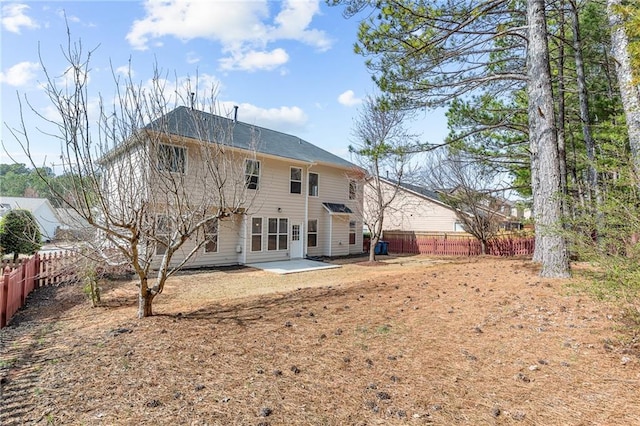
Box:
[145,106,355,167]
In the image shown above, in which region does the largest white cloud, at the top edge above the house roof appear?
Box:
[127,0,331,70]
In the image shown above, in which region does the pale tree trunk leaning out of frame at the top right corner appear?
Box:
[607,0,640,181]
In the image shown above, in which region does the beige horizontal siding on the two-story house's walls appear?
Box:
[132,135,362,267]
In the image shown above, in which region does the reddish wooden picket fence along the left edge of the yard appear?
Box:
[0,252,78,328]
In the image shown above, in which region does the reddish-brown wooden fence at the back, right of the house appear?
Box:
[382,232,534,256]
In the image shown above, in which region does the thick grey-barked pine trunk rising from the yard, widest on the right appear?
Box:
[527,0,570,278]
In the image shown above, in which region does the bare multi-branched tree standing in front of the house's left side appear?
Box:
[5,32,257,318]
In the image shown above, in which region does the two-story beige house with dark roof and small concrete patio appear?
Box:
[104,107,363,267]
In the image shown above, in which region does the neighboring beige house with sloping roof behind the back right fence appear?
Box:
[365,179,519,233]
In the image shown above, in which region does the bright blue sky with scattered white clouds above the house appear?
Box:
[0,0,446,170]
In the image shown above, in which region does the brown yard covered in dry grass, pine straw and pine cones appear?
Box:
[0,257,640,426]
